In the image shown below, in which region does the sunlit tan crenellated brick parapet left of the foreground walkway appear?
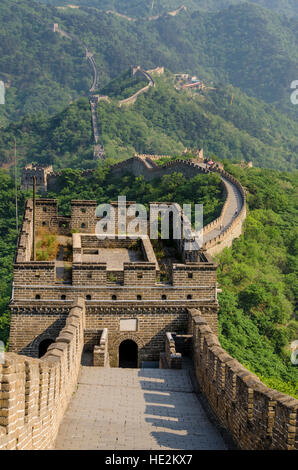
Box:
[0,300,85,450]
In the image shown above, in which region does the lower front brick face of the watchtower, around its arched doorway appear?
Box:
[9,298,218,360]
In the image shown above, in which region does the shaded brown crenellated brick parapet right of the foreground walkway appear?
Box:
[189,310,298,450]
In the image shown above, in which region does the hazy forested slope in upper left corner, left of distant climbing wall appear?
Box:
[0,0,92,125]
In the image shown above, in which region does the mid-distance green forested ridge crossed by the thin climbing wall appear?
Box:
[0,73,298,170]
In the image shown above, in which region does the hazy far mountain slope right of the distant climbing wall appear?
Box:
[55,3,298,116]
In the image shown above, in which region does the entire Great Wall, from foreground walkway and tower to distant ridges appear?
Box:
[0,16,298,450]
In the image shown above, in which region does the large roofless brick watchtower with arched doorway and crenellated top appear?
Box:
[9,198,218,367]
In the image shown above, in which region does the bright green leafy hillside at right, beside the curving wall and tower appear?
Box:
[218,164,298,396]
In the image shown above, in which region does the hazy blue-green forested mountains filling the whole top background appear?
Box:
[0,0,298,125]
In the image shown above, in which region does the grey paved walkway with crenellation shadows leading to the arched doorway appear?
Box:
[56,366,227,450]
